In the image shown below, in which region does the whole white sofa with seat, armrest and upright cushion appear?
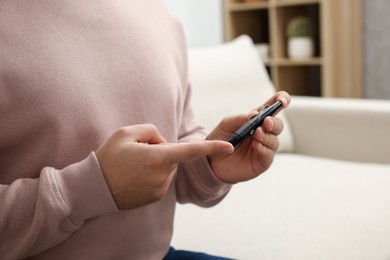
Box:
[172,36,390,260]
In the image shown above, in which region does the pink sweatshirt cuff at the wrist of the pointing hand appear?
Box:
[53,152,118,226]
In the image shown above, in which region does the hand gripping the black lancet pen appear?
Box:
[208,91,291,183]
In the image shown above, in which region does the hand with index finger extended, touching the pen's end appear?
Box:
[96,124,234,209]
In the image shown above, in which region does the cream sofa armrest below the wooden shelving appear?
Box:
[286,96,390,164]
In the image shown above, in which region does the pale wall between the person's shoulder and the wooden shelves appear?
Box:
[163,0,223,48]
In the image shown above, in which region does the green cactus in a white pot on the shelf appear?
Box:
[287,16,314,59]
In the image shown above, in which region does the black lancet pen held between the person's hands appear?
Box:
[228,101,282,147]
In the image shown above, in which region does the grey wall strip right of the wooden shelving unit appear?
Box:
[363,0,390,99]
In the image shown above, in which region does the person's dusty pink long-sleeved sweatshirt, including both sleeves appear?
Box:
[0,0,230,259]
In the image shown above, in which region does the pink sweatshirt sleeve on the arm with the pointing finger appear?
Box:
[0,153,118,259]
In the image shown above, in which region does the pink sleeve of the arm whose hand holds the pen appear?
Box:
[176,81,231,207]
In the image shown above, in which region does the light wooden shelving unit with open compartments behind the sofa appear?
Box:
[224,0,363,98]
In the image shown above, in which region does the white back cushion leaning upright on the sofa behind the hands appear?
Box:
[189,35,293,152]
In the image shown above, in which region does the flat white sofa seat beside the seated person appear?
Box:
[172,153,390,260]
